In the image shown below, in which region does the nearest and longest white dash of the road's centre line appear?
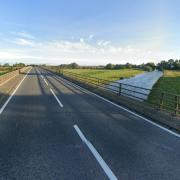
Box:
[73,125,118,180]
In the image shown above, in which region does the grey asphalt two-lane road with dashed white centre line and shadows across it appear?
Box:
[0,68,180,180]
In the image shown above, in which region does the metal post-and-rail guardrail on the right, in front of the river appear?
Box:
[46,70,180,116]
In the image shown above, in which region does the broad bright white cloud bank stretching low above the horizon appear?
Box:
[0,33,177,65]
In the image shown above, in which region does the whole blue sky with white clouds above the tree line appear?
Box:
[0,0,180,65]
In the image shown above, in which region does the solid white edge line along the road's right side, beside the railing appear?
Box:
[44,69,180,138]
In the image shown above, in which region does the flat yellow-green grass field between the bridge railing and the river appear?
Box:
[64,69,144,81]
